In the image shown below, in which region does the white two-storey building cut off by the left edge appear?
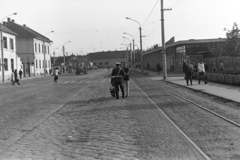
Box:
[0,24,22,81]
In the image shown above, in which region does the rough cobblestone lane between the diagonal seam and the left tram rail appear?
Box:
[0,72,205,160]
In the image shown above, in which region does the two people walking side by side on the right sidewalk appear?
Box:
[183,60,208,85]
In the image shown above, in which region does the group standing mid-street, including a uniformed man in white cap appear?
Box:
[111,62,129,99]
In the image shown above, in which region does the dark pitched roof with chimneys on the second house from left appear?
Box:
[6,20,52,43]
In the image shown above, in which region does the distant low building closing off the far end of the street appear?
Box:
[87,51,129,68]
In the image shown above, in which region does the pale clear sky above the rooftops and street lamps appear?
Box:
[0,0,240,56]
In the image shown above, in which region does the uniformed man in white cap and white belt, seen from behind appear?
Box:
[111,62,125,99]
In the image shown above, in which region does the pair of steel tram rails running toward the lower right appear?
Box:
[132,74,240,160]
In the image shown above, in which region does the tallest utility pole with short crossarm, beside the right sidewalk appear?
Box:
[161,0,172,80]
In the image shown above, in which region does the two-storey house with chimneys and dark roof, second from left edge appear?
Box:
[6,18,52,77]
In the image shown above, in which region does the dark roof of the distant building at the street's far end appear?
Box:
[88,51,126,60]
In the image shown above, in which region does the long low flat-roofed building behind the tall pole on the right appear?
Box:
[143,38,226,72]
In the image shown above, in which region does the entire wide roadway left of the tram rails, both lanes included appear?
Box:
[0,69,206,160]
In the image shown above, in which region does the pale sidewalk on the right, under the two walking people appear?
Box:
[136,69,240,102]
